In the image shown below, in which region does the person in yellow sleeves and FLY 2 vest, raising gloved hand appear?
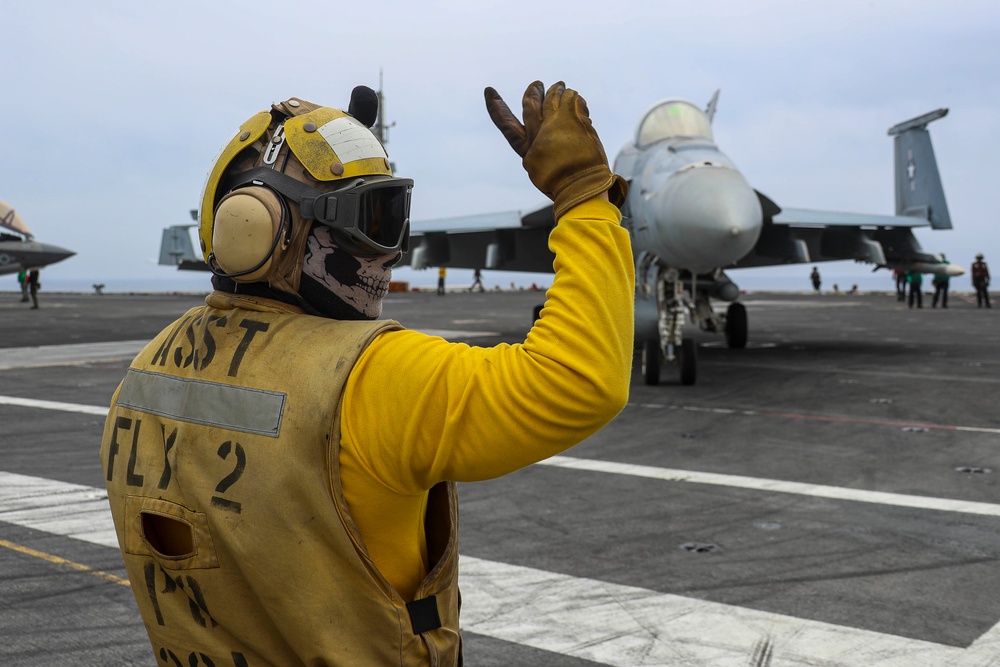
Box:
[101,81,635,667]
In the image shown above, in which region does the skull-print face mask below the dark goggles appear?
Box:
[299,224,402,320]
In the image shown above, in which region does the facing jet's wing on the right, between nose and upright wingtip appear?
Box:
[731,193,941,268]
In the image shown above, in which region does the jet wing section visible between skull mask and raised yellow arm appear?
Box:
[398,204,555,273]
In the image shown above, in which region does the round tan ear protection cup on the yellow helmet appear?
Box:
[209,186,289,282]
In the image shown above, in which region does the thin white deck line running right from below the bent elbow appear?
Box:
[535,456,1000,517]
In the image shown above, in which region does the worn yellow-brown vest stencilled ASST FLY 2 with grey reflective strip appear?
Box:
[101,297,461,667]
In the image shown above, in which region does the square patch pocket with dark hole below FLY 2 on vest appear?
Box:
[124,496,219,570]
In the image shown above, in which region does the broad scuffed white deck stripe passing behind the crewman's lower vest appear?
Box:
[0,472,1000,667]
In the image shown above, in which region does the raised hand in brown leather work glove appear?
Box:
[485,81,628,221]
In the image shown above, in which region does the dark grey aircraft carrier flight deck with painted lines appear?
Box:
[0,290,1000,667]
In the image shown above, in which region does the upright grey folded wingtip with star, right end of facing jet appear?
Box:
[889,109,951,229]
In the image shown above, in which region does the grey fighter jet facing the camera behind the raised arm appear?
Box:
[394,92,962,385]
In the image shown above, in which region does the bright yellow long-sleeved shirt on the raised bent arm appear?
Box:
[340,199,635,599]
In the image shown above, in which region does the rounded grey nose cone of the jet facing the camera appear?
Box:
[659,166,763,273]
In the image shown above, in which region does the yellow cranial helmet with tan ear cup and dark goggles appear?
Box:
[199,92,413,292]
